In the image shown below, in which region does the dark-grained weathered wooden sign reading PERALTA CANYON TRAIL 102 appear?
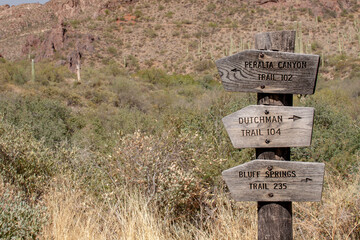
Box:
[216,50,320,94]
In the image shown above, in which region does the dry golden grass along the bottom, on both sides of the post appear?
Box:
[42,168,360,240]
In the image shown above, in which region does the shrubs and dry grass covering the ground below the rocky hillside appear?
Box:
[0,50,360,239]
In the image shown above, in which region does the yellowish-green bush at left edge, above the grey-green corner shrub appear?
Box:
[0,119,56,197]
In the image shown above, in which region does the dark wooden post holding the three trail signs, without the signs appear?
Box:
[255,31,295,240]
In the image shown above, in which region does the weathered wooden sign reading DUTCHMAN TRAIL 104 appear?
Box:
[222,105,314,148]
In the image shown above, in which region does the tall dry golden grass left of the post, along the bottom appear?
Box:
[41,181,256,240]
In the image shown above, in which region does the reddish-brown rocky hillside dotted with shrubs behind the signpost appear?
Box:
[0,0,360,72]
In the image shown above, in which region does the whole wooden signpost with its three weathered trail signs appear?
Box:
[216,31,324,240]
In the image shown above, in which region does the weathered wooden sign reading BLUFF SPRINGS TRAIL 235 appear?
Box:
[222,160,325,202]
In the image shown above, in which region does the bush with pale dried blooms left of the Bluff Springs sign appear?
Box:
[112,132,202,217]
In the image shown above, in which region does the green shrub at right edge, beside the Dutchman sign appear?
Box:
[292,91,360,176]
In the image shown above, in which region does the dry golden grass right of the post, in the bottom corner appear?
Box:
[294,169,360,240]
